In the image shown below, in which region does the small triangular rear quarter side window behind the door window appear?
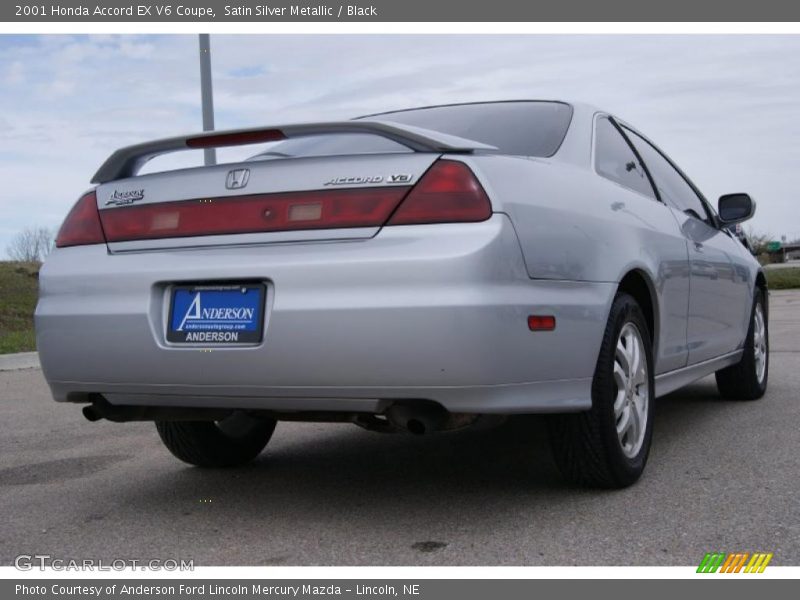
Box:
[594,117,656,199]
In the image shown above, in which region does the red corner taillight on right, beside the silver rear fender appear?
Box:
[387,160,492,225]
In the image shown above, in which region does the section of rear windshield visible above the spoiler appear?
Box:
[362,102,572,156]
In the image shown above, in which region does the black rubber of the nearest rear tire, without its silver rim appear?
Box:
[548,293,655,488]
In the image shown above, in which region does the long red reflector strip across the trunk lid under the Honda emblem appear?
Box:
[100,187,408,242]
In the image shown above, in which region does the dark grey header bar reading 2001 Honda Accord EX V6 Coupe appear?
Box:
[6,0,800,23]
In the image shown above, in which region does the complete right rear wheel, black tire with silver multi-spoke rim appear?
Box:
[549,293,655,488]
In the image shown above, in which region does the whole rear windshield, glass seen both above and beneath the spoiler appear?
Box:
[250,102,572,160]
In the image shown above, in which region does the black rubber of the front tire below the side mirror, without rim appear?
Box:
[715,288,769,400]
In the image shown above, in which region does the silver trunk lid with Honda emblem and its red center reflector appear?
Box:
[96,152,440,252]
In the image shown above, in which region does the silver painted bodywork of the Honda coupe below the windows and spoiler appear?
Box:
[36,104,760,413]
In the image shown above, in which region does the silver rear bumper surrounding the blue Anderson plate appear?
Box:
[36,214,615,413]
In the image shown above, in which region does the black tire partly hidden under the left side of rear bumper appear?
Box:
[156,412,275,467]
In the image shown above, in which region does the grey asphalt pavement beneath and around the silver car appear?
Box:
[0,292,800,565]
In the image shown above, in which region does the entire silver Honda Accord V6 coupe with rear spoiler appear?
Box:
[36,101,769,487]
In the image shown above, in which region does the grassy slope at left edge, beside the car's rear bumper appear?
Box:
[0,262,39,354]
